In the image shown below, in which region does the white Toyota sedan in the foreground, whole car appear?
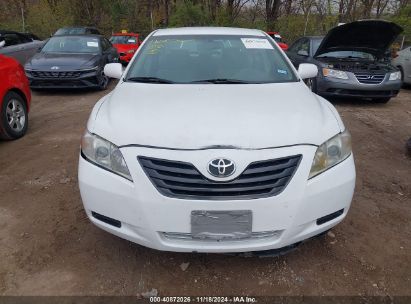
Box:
[79,27,355,252]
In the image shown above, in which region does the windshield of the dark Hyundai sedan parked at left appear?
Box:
[41,37,100,53]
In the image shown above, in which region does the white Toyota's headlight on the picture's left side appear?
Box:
[81,131,133,181]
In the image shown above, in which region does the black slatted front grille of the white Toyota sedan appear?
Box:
[138,155,301,200]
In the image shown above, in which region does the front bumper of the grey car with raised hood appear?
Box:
[317,72,401,98]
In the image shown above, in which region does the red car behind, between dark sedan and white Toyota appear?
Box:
[110,33,141,63]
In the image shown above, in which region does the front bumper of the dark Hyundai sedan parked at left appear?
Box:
[26,71,101,89]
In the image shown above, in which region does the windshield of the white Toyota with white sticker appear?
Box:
[126,35,298,83]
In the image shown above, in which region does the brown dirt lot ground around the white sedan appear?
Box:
[0,84,411,296]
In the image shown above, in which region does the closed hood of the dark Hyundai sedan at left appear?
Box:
[25,52,101,71]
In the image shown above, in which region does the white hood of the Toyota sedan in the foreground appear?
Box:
[88,82,341,149]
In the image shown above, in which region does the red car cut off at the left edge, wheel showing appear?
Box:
[0,55,31,140]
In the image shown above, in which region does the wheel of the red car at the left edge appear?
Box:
[0,92,29,140]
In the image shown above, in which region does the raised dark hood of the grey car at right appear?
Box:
[314,20,403,57]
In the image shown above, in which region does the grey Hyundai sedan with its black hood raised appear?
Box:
[287,20,402,103]
